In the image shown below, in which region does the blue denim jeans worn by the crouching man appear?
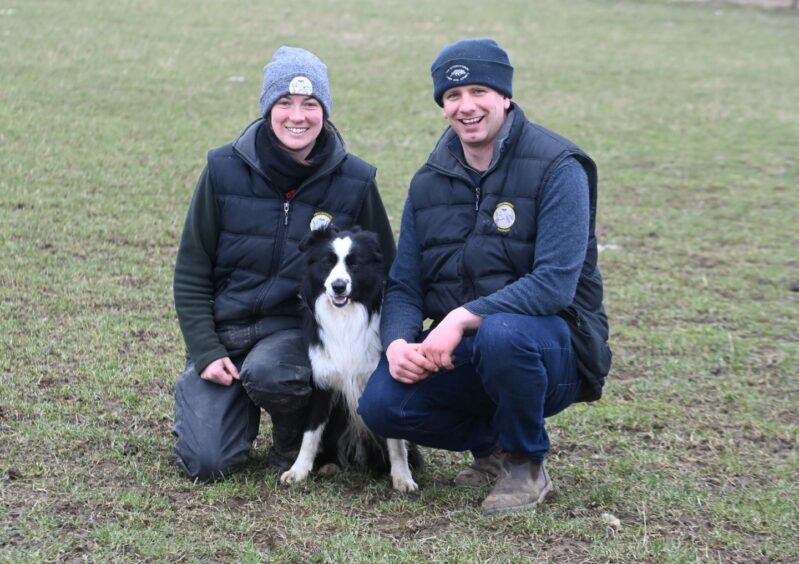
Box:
[358,313,580,461]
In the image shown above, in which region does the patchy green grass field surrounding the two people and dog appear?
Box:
[0,0,799,562]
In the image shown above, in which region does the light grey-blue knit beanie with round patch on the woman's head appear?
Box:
[261,45,333,118]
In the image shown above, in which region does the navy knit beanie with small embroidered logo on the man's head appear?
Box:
[430,39,513,107]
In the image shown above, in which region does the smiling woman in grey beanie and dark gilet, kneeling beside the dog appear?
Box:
[173,47,396,480]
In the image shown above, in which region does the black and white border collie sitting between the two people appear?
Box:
[280,226,421,492]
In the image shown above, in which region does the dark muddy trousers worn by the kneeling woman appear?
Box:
[172,330,311,481]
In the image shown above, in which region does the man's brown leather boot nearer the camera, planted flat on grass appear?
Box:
[480,453,555,515]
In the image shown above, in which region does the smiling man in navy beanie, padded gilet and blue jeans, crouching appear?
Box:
[359,39,611,514]
